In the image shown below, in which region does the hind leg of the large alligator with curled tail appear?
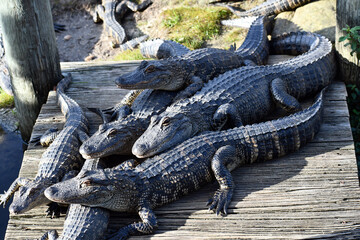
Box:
[270,78,301,112]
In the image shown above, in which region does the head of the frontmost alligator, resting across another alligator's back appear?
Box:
[45,169,139,211]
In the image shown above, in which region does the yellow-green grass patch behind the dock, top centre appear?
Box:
[161,7,231,49]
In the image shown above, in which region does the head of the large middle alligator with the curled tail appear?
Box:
[132,112,195,158]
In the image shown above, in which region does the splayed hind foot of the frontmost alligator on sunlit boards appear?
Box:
[206,189,233,216]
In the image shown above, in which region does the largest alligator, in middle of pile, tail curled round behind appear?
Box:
[132,32,336,158]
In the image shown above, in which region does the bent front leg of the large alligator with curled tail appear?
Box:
[212,103,243,131]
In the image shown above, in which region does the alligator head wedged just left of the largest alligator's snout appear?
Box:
[79,117,145,159]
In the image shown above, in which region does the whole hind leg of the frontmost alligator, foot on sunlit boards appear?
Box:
[207,146,236,215]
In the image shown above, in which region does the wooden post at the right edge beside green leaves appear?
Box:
[335,0,360,87]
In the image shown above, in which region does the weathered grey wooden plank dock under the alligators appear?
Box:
[5,57,360,239]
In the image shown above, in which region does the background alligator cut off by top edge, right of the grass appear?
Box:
[216,0,312,28]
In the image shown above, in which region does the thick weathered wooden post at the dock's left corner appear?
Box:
[0,0,61,141]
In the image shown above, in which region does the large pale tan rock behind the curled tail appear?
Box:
[272,0,336,42]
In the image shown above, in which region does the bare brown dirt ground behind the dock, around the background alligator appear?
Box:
[52,0,179,62]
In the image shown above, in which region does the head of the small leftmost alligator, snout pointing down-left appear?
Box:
[9,179,51,214]
